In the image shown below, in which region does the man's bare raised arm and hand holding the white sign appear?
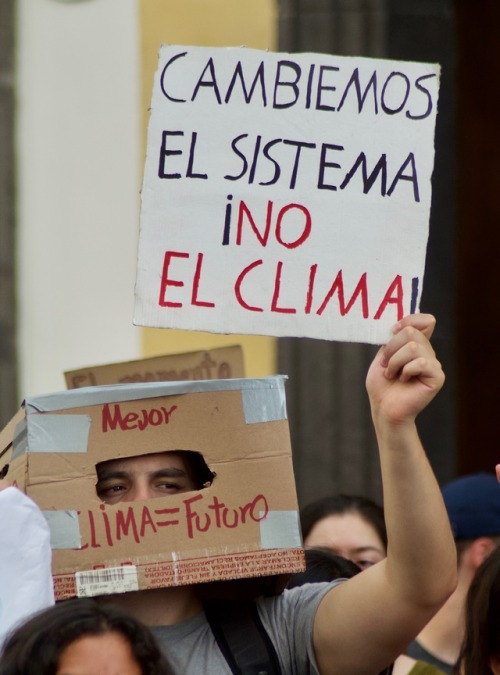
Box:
[314,314,457,675]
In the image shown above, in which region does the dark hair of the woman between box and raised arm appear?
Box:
[300,494,387,550]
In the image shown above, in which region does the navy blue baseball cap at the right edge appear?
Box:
[442,473,500,539]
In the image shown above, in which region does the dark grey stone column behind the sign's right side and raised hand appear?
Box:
[278,0,456,504]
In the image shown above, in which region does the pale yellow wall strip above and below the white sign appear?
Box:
[139,0,277,377]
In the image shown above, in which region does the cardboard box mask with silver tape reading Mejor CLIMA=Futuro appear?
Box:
[3,376,304,599]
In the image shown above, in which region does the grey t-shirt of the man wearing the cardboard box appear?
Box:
[152,582,338,675]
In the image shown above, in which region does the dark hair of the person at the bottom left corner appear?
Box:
[0,598,172,675]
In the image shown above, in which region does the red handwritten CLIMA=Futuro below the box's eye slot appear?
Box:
[80,494,269,549]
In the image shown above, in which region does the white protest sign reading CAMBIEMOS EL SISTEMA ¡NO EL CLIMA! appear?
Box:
[134,46,439,344]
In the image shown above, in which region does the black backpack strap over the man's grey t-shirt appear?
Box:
[204,600,281,675]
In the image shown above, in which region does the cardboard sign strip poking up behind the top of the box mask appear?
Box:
[64,345,245,389]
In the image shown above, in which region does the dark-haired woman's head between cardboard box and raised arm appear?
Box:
[300,494,387,569]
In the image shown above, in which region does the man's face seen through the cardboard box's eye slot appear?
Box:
[96,452,196,504]
